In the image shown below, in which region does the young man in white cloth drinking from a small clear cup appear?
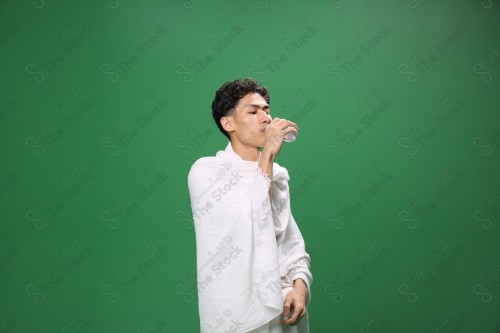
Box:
[188,78,312,333]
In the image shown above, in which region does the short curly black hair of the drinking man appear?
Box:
[212,78,271,140]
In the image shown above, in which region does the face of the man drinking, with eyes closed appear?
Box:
[221,93,272,147]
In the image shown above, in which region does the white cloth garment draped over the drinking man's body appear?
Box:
[188,142,312,333]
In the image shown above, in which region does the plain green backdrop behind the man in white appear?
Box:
[0,0,500,333]
